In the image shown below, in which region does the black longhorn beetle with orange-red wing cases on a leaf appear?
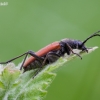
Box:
[0,31,100,72]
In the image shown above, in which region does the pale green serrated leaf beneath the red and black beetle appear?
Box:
[0,47,97,100]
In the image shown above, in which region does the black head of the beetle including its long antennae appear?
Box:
[78,31,100,52]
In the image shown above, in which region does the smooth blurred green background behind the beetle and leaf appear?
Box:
[0,0,100,100]
